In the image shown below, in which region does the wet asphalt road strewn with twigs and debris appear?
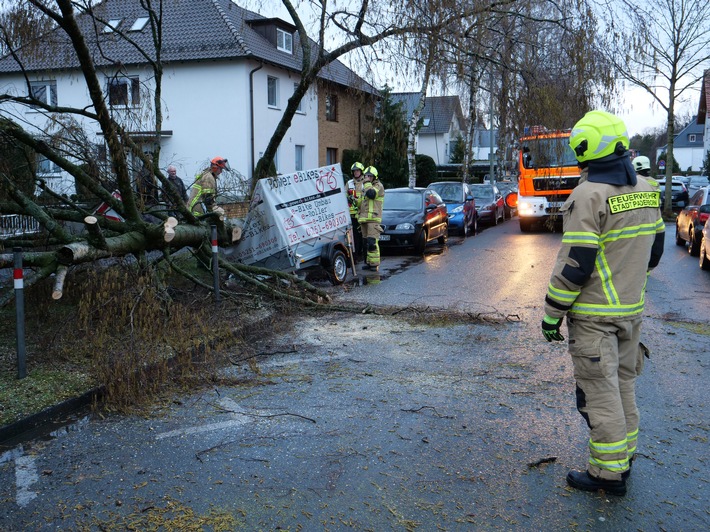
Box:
[0,220,710,531]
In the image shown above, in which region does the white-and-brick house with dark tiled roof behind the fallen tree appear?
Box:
[0,0,376,194]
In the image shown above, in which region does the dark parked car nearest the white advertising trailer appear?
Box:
[379,188,449,255]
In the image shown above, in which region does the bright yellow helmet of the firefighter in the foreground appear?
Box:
[569,111,629,163]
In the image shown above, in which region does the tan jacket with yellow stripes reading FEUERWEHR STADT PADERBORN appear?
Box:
[545,169,665,322]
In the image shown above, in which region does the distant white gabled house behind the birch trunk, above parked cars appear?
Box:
[392,92,466,165]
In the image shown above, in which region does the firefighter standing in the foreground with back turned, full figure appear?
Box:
[542,111,665,495]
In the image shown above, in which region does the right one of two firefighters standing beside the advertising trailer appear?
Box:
[357,166,385,271]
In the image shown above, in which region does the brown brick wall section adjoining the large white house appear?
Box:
[318,80,374,166]
